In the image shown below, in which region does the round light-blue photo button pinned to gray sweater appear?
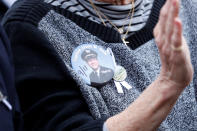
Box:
[71,44,115,87]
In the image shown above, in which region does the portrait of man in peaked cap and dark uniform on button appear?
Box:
[81,49,114,86]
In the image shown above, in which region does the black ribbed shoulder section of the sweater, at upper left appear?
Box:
[2,0,51,25]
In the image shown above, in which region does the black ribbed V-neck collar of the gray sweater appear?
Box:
[53,0,166,49]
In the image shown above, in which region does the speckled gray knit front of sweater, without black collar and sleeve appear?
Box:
[2,0,197,131]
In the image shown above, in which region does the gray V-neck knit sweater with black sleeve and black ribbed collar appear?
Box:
[4,0,197,131]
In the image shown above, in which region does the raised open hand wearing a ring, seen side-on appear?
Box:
[154,0,193,88]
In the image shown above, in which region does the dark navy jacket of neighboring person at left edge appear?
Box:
[0,25,22,131]
